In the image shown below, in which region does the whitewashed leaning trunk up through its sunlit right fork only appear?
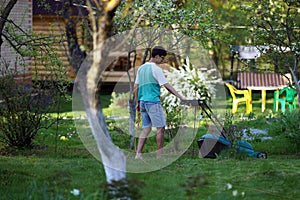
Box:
[85,0,126,182]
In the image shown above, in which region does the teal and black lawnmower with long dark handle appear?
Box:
[181,99,267,159]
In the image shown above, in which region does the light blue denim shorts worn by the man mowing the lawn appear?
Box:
[140,101,166,128]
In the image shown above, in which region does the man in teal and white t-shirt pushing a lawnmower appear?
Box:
[134,46,184,159]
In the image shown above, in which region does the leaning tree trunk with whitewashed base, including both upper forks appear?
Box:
[64,0,126,182]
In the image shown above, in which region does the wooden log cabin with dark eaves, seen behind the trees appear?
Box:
[32,0,141,84]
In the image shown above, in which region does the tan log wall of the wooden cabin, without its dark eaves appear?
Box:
[33,15,141,83]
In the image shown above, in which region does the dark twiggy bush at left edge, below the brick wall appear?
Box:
[0,75,65,149]
